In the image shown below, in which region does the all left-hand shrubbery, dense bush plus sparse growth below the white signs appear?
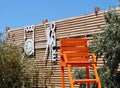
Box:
[0,33,55,88]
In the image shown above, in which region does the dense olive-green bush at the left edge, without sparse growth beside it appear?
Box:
[0,32,32,88]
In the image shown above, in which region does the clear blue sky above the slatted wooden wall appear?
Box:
[0,0,119,32]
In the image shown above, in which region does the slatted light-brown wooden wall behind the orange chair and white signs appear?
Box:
[6,8,120,88]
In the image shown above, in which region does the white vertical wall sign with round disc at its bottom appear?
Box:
[24,25,34,56]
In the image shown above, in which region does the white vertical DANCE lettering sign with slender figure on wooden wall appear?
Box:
[44,22,56,62]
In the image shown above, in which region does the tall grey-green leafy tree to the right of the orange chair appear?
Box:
[90,9,120,88]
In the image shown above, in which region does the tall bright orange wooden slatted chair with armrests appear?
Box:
[60,38,101,88]
